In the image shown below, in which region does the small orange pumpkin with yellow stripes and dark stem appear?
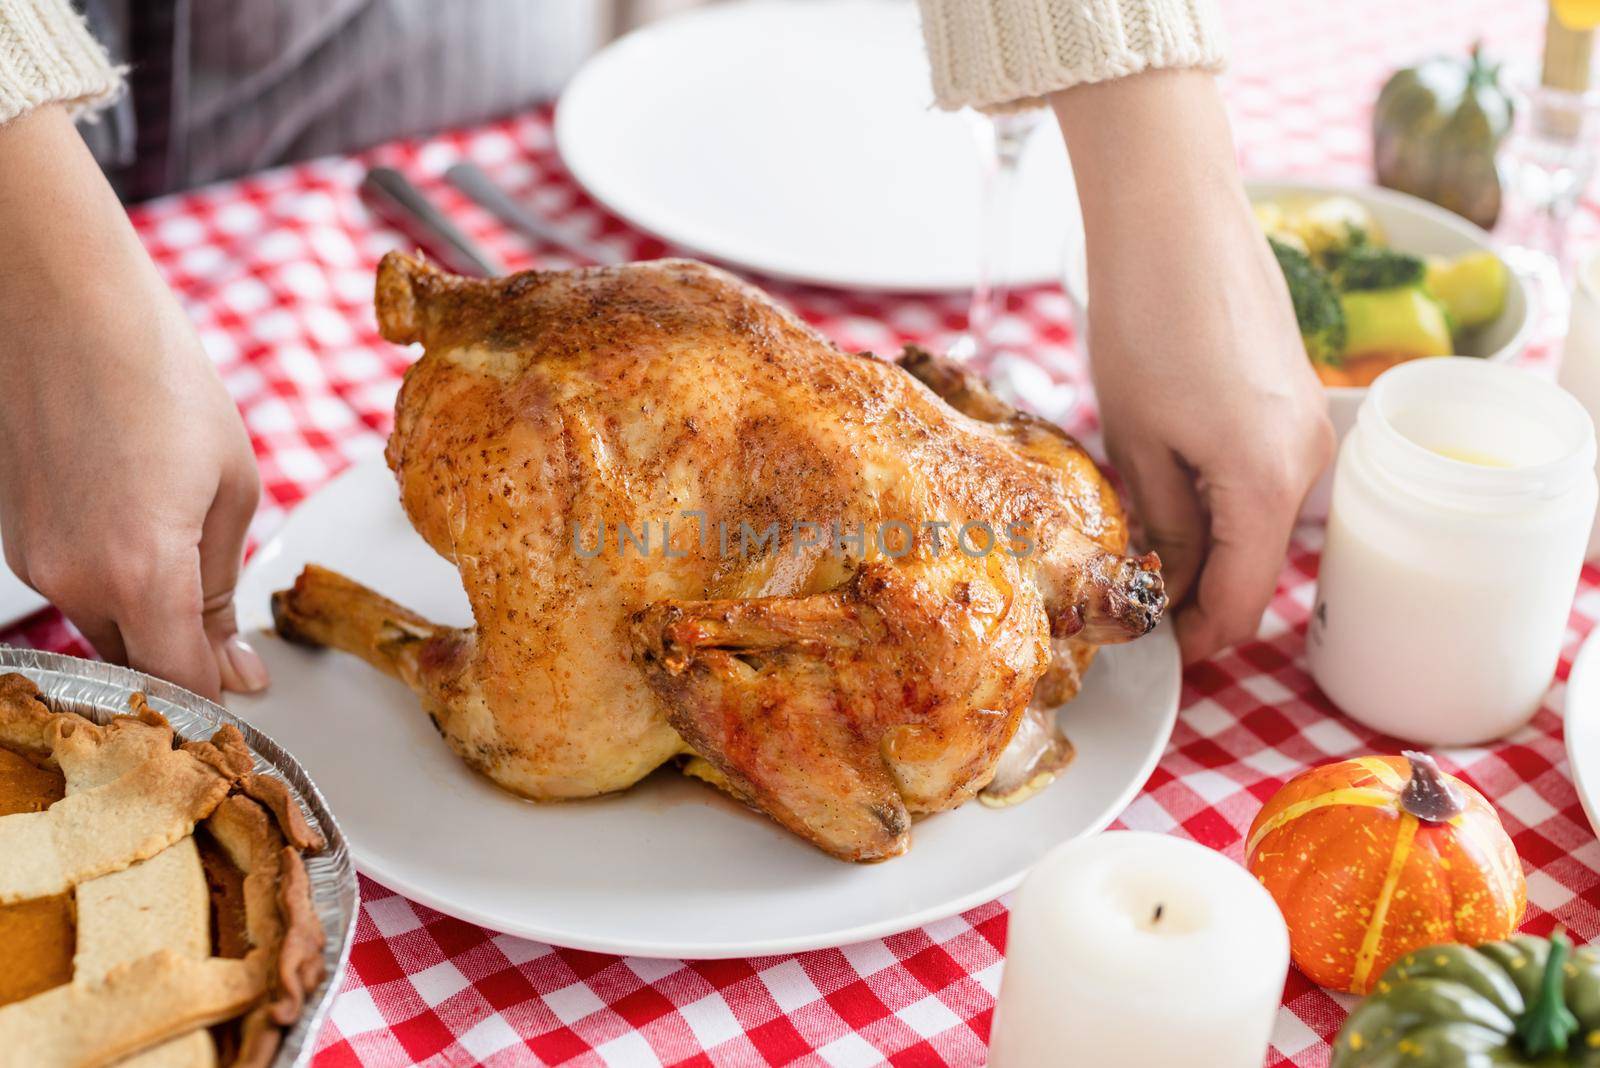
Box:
[1245,753,1528,994]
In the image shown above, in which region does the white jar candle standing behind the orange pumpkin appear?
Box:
[1306,357,1595,745]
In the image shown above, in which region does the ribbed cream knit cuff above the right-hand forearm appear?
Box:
[920,0,1222,110]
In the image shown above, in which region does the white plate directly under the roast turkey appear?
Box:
[229,457,1181,958]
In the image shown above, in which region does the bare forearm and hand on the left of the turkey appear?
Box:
[0,107,267,699]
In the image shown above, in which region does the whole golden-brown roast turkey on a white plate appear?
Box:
[274,253,1166,860]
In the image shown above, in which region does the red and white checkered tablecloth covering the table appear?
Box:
[0,0,1600,1068]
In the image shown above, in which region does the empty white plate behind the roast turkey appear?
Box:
[555,0,1082,291]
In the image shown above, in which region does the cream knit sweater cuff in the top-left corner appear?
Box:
[0,0,122,123]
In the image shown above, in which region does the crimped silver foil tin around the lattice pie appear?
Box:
[0,646,358,1068]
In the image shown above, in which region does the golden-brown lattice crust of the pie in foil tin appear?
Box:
[0,675,323,1068]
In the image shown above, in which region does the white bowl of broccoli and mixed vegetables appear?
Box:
[1066,181,1533,521]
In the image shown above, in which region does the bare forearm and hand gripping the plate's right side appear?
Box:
[1051,70,1333,664]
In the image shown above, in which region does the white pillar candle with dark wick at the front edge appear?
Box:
[989,831,1290,1068]
